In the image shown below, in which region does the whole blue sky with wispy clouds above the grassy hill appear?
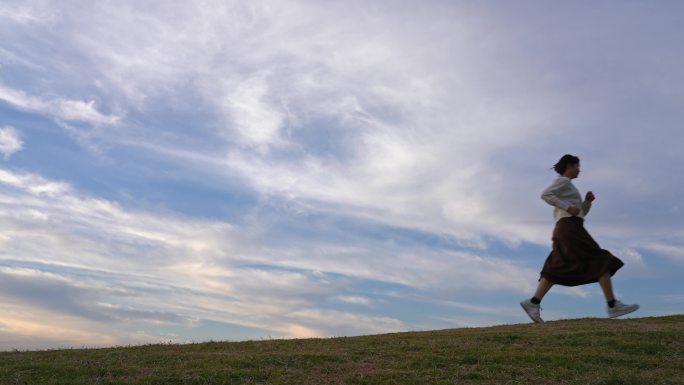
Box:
[0,0,684,350]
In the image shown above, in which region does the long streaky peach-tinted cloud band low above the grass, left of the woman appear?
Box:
[0,165,533,348]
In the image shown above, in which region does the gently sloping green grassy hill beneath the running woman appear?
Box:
[0,315,684,385]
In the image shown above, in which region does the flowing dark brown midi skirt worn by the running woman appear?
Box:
[540,217,624,286]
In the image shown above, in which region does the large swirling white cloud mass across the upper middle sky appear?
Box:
[2,1,656,248]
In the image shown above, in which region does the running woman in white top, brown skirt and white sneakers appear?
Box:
[520,154,639,322]
